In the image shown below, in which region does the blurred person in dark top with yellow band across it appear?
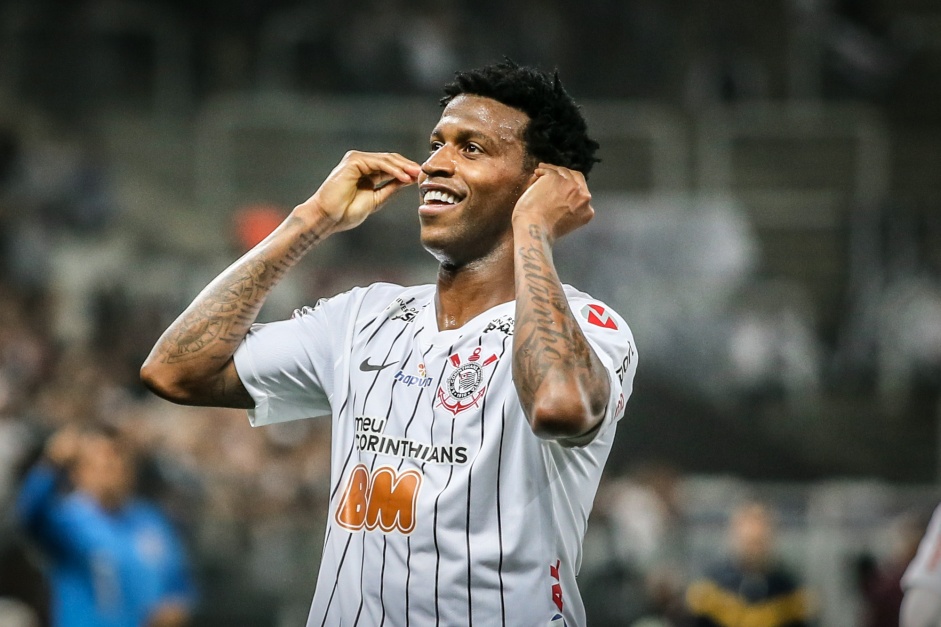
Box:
[686,502,813,627]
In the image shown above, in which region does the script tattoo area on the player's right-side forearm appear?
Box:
[513,225,607,418]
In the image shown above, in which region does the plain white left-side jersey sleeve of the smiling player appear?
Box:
[235,292,353,427]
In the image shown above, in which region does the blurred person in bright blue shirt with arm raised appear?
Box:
[17,427,195,627]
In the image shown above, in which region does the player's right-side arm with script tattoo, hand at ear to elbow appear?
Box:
[513,163,610,444]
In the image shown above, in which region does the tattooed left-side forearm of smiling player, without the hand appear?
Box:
[141,214,334,407]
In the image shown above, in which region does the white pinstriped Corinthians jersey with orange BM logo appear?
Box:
[235,284,637,627]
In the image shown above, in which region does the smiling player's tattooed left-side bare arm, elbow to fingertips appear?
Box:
[141,152,420,408]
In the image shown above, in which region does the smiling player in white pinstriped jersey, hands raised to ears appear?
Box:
[142,62,636,627]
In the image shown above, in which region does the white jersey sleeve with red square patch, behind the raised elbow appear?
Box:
[569,297,637,440]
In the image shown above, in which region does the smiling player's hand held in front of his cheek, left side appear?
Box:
[295,150,421,231]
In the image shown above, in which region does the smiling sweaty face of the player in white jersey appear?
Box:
[418,94,534,266]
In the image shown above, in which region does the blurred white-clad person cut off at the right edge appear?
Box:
[899,505,941,627]
